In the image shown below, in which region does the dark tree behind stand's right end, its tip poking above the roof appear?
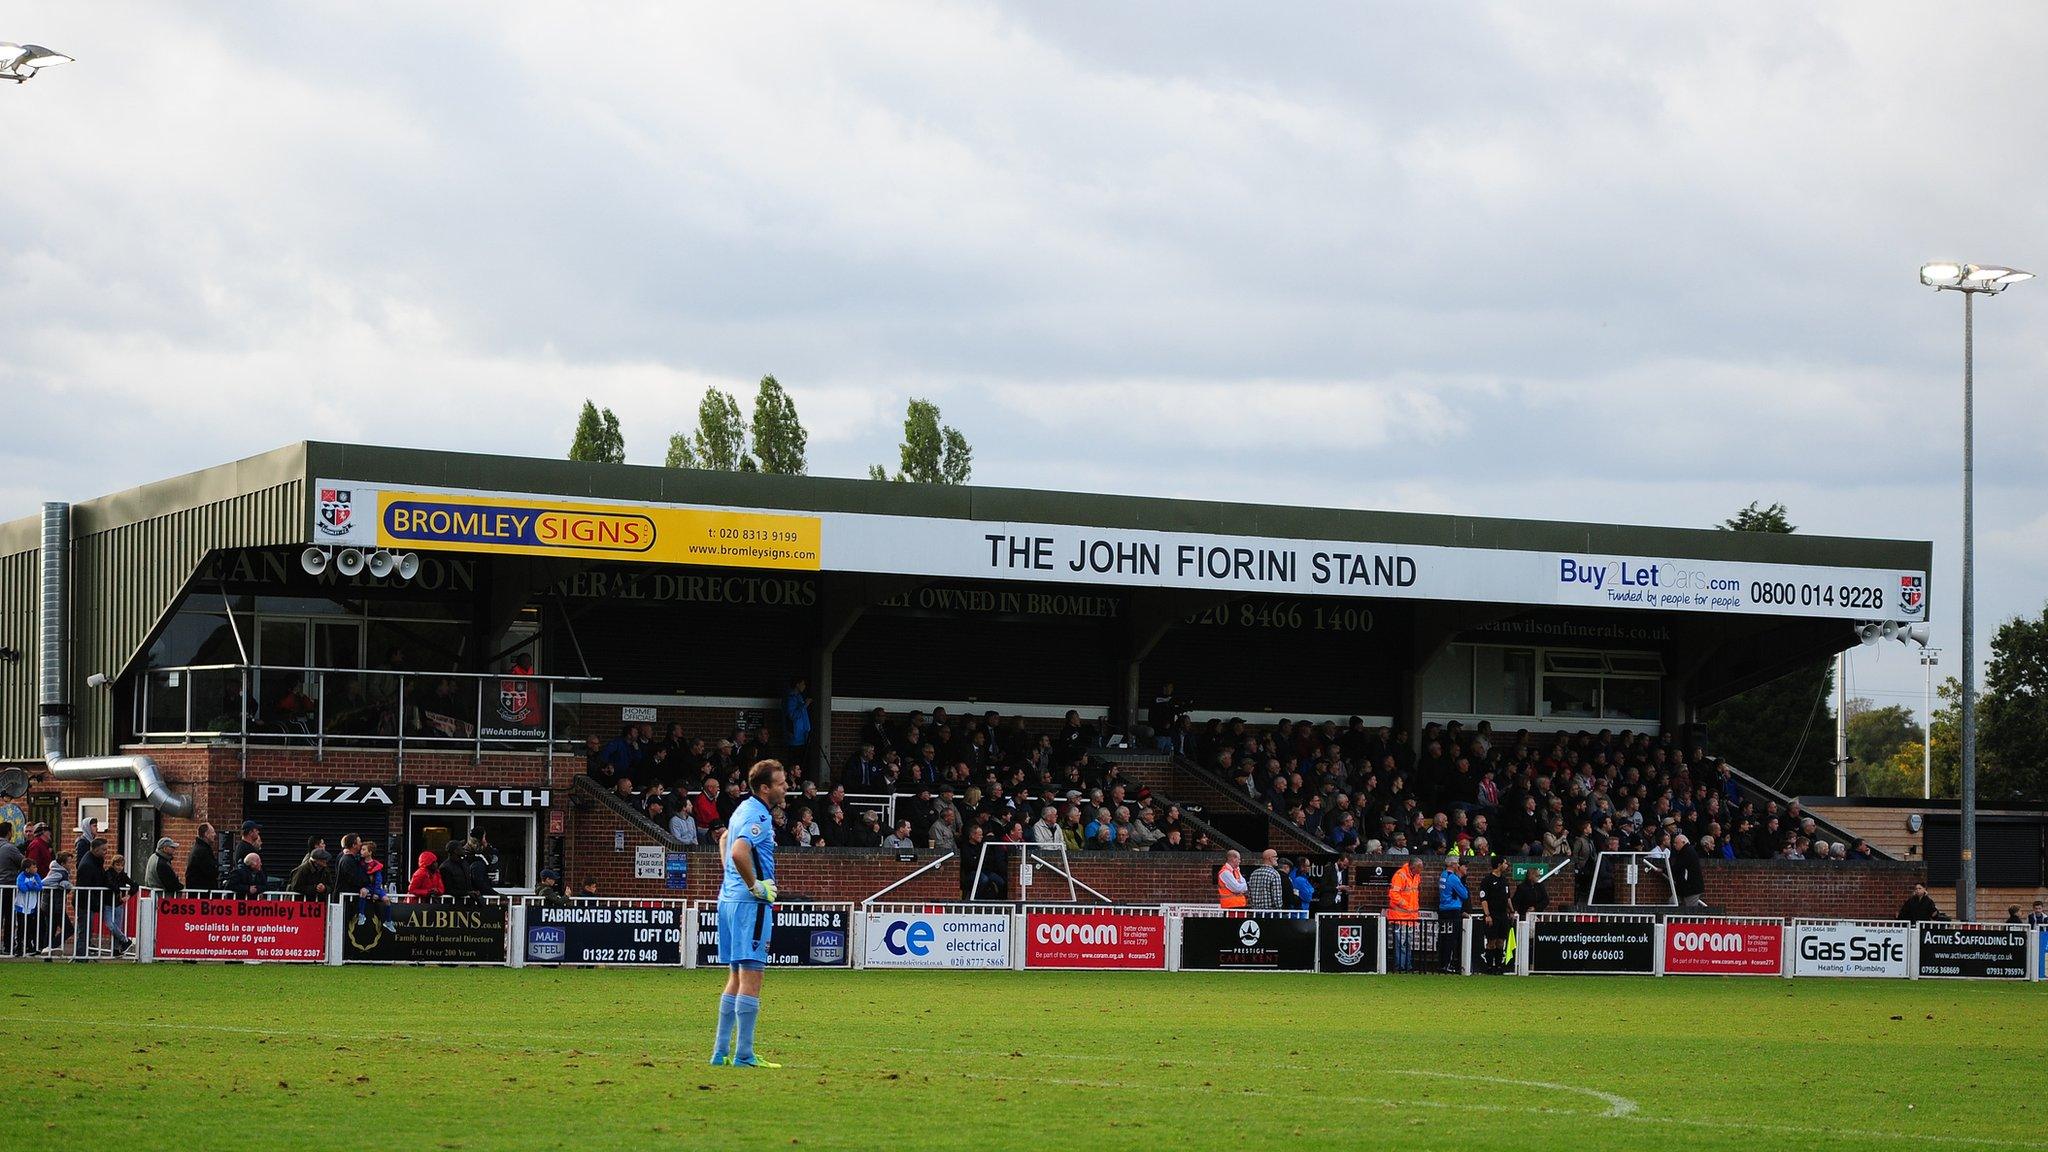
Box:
[1702,500,1835,795]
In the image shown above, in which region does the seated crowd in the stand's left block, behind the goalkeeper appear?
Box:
[584,707,1214,859]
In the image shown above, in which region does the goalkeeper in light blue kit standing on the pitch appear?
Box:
[711,760,788,1068]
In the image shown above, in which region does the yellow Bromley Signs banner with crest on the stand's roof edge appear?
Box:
[313,482,821,572]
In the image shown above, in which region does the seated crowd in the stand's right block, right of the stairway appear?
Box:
[1161,715,1874,865]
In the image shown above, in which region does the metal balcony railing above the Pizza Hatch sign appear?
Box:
[133,664,596,767]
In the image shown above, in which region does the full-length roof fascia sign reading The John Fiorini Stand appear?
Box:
[309,480,1927,621]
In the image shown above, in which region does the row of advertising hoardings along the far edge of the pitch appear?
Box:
[119,898,2048,980]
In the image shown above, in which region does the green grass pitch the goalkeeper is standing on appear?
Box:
[0,963,2048,1152]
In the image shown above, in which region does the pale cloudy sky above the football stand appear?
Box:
[0,0,2048,707]
